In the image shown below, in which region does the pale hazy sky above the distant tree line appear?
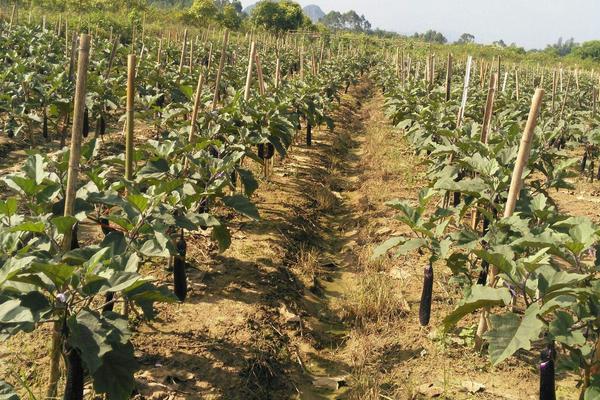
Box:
[242,0,600,48]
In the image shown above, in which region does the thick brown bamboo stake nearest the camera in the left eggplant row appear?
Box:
[46,34,90,398]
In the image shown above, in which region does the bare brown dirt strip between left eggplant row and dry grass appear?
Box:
[135,79,376,399]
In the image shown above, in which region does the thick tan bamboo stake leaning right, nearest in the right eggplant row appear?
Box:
[476,89,544,347]
